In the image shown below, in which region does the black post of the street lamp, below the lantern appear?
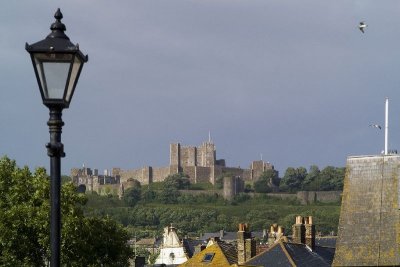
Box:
[46,107,65,267]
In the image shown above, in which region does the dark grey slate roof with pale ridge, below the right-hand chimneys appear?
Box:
[244,240,335,267]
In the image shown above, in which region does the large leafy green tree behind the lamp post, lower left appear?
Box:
[0,157,132,266]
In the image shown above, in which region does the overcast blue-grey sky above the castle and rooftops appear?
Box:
[0,0,400,175]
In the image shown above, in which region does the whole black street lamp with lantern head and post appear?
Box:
[25,9,88,267]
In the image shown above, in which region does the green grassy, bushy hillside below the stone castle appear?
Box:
[84,194,340,240]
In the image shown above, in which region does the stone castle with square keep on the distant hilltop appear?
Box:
[71,139,274,193]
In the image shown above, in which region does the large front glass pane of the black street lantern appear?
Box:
[43,62,70,99]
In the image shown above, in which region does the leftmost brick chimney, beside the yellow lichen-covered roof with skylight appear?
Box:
[237,223,256,264]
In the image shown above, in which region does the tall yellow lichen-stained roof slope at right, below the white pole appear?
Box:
[333,155,400,266]
